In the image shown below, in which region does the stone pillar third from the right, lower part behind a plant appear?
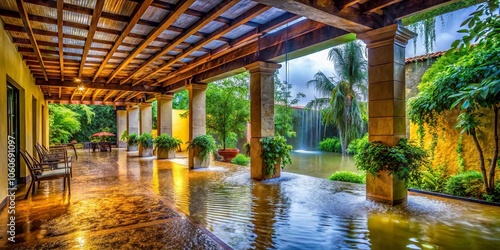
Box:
[187,83,207,168]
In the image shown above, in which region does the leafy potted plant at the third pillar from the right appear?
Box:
[188,135,217,168]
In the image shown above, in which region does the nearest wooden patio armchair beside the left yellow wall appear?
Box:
[20,150,71,199]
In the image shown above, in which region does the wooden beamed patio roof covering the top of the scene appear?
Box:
[0,0,455,106]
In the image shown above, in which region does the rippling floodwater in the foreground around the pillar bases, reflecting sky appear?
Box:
[145,152,500,249]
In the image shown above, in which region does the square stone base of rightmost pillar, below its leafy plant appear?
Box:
[366,171,408,205]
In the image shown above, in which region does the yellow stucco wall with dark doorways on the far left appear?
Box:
[0,20,48,201]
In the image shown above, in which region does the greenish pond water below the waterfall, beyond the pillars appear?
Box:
[283,150,357,179]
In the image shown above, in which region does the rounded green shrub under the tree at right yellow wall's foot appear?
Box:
[445,171,483,198]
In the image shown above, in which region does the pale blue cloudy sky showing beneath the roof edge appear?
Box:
[279,7,475,105]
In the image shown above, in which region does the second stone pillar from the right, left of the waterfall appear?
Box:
[245,62,281,180]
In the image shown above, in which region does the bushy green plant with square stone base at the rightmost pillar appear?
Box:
[354,138,427,205]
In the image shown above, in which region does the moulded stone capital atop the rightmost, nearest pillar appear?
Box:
[357,24,415,49]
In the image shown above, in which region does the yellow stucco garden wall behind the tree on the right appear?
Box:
[410,110,500,178]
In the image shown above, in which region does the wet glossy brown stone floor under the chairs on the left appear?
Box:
[0,151,228,249]
